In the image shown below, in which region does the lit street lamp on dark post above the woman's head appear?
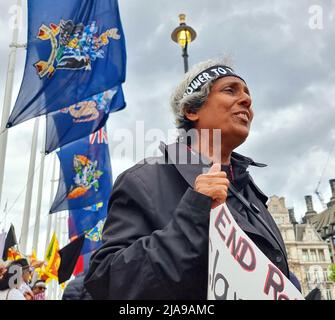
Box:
[171,13,197,73]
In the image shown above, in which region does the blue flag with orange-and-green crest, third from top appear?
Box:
[50,128,113,213]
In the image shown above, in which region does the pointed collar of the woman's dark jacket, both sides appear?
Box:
[159,141,266,188]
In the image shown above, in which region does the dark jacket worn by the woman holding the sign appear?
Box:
[85,144,288,300]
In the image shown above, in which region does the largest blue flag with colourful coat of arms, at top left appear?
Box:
[7,0,126,127]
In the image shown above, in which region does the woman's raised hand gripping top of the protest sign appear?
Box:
[194,163,229,209]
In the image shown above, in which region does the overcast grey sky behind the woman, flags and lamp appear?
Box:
[0,0,335,255]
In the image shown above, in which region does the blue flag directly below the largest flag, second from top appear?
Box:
[45,86,125,153]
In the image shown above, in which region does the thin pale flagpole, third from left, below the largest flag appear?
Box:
[32,121,46,256]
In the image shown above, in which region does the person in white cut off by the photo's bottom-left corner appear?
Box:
[0,261,26,300]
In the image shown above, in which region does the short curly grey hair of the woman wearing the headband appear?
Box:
[171,57,233,131]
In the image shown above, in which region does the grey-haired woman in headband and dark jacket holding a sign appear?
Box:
[85,60,300,299]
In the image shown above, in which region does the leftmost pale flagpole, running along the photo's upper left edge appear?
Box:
[0,0,26,204]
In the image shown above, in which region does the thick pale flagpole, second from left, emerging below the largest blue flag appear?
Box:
[20,118,39,254]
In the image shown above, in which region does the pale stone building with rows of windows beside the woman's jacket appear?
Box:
[268,196,335,300]
